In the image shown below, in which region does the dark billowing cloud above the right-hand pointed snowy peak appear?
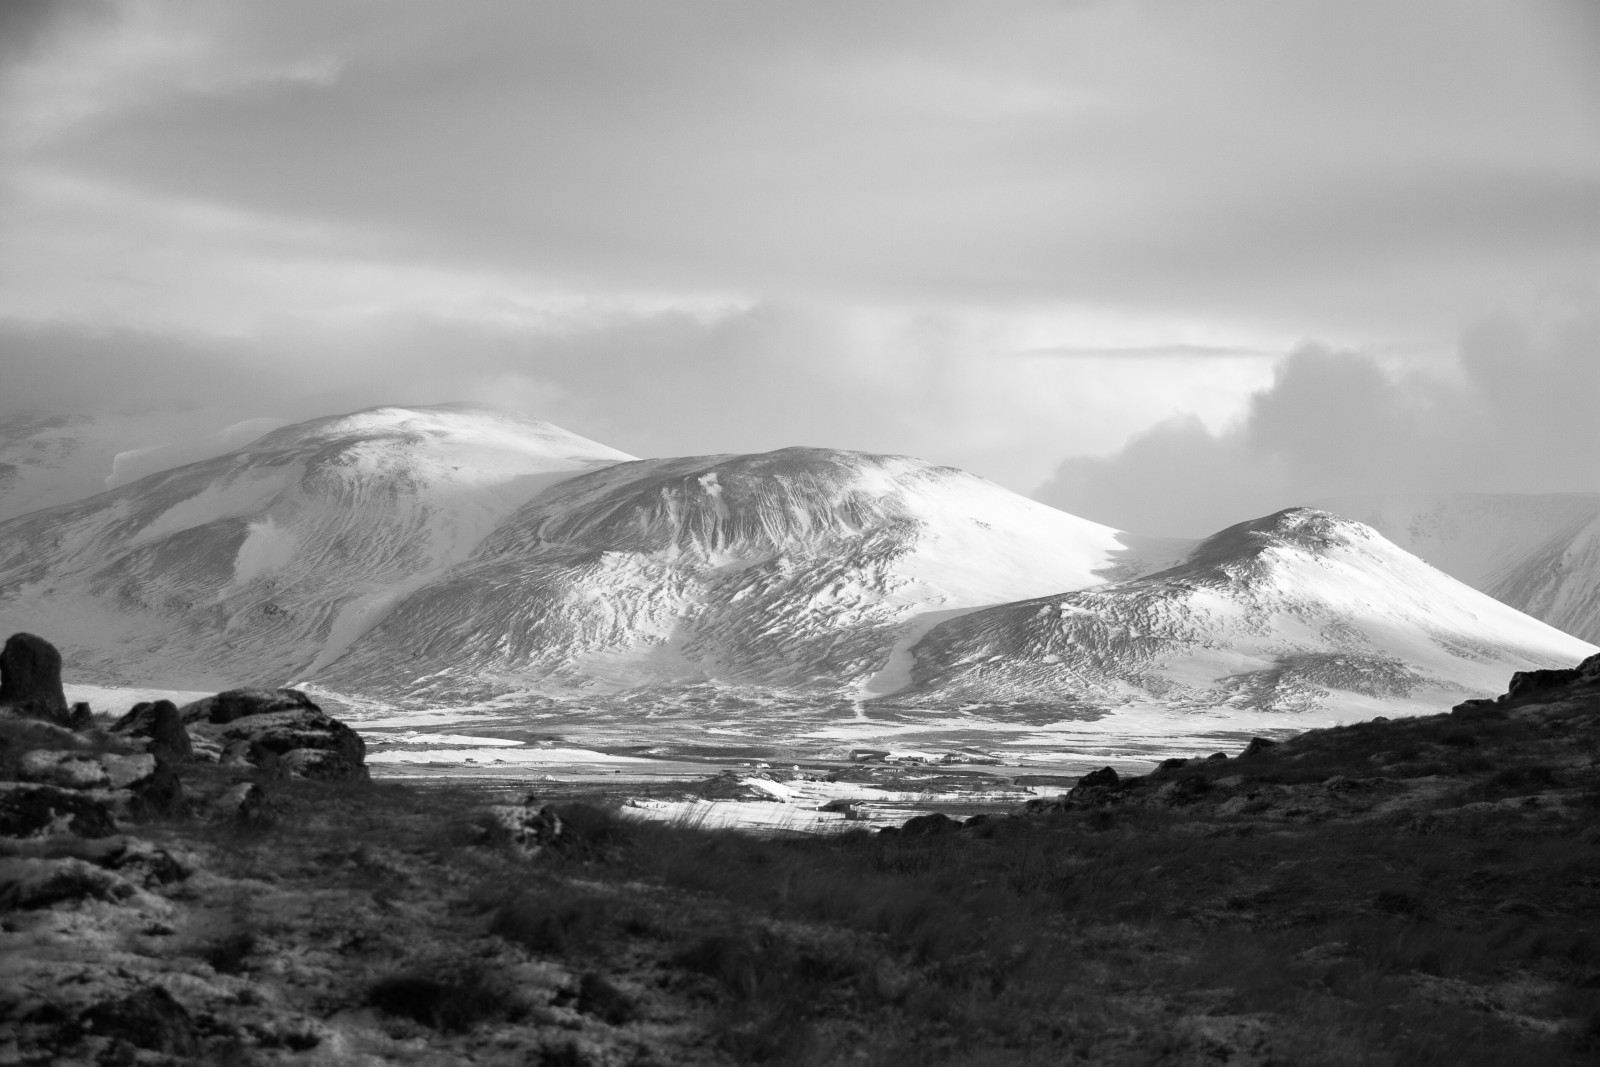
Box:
[1035,298,1600,536]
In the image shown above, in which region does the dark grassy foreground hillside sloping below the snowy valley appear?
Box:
[9,659,1600,1067]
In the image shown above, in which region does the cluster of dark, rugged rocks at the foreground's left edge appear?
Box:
[0,633,366,1064]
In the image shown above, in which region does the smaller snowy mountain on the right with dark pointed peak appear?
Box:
[902,509,1594,715]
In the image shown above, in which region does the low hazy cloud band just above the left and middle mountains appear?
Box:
[0,302,1270,491]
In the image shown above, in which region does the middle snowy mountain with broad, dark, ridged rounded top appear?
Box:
[315,448,1184,701]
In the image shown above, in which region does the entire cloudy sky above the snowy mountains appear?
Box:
[0,0,1600,534]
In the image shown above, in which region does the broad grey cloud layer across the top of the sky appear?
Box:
[11,0,1600,336]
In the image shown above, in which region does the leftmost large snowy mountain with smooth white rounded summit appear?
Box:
[0,405,629,688]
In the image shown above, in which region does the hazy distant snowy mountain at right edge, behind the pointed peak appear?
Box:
[1326,493,1600,641]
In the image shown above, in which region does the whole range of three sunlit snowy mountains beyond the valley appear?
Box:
[0,405,1594,713]
